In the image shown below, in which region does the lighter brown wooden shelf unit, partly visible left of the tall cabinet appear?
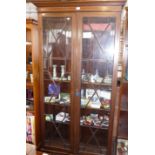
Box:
[26,19,39,144]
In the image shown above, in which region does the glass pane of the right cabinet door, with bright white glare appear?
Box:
[80,17,115,154]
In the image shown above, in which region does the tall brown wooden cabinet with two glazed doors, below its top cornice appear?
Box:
[30,2,126,155]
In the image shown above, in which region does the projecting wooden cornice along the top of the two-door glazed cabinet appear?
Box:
[26,0,127,7]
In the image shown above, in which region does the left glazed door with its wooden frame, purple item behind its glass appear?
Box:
[40,13,75,152]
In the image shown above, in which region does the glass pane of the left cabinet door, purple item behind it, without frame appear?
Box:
[43,17,72,148]
